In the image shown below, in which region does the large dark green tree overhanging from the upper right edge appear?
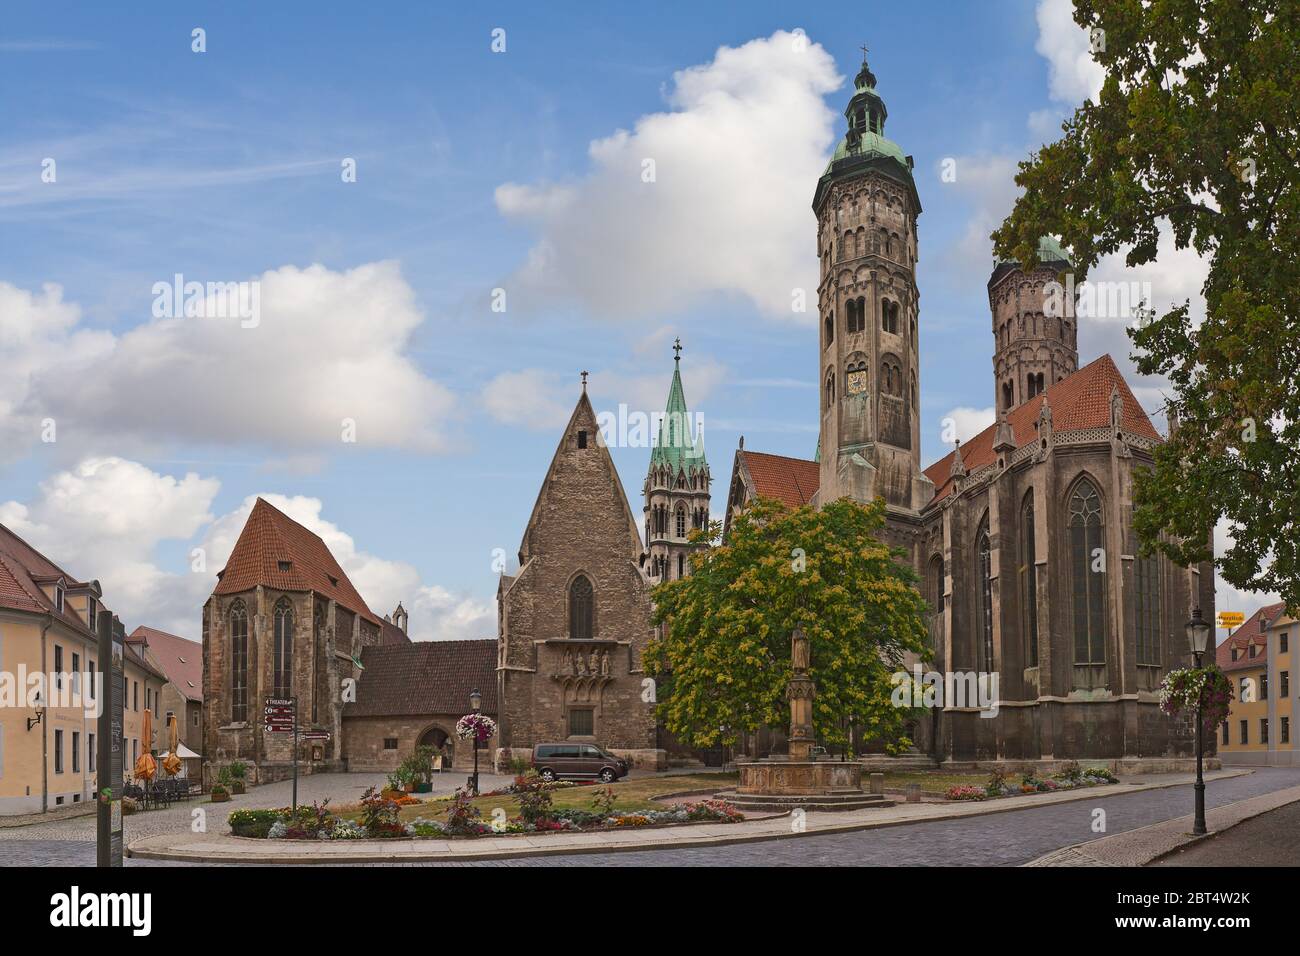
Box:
[993,0,1300,607]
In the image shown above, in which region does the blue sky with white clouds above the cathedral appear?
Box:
[0,0,1268,640]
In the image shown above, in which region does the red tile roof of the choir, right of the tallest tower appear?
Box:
[926,355,1160,501]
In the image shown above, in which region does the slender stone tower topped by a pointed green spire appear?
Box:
[645,339,711,584]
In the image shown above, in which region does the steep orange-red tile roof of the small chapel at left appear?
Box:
[215,498,384,627]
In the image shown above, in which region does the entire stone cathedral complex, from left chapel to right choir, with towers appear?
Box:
[203,54,1214,779]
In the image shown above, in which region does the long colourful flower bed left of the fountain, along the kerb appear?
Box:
[230,774,745,840]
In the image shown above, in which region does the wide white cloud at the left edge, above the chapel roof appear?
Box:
[0,261,454,465]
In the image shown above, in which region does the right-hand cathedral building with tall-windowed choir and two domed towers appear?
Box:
[728,54,1214,766]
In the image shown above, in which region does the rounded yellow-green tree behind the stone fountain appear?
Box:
[645,498,928,752]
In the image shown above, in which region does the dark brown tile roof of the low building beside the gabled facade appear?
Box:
[343,639,497,717]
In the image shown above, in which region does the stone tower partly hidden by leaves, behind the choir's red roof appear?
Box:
[988,237,1079,412]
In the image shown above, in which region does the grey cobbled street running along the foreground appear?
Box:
[0,769,1300,866]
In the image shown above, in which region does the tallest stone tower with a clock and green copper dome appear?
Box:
[813,57,935,514]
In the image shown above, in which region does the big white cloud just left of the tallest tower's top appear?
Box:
[497,31,841,320]
